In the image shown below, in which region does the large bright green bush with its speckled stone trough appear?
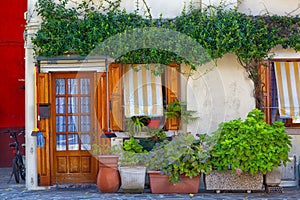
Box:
[205,109,291,192]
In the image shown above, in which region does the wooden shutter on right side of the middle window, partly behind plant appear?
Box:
[165,63,180,130]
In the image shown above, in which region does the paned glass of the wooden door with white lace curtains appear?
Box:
[55,78,91,151]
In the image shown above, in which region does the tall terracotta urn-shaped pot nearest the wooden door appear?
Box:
[92,143,121,193]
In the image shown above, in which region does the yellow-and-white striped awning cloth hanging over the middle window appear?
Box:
[123,65,163,117]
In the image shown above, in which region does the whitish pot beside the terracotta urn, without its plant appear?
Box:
[120,166,146,193]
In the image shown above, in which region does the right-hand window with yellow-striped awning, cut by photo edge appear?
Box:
[266,60,300,127]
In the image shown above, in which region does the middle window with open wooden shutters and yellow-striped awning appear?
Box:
[109,64,180,131]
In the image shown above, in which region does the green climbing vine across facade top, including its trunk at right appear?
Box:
[32,0,300,108]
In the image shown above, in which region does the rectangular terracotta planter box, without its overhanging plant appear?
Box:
[147,171,200,194]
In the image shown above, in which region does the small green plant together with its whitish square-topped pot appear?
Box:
[119,137,146,193]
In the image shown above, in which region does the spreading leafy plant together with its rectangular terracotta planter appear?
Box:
[144,133,211,193]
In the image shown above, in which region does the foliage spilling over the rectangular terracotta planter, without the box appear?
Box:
[144,133,211,184]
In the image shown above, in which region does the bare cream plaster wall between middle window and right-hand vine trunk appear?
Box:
[187,54,255,134]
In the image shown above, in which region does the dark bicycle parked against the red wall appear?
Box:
[6,129,26,183]
